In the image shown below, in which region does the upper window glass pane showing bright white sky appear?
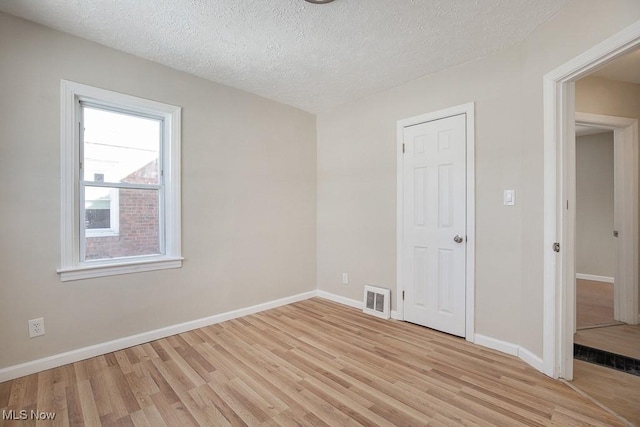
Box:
[82,106,162,184]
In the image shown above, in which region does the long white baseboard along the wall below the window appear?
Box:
[0,291,318,383]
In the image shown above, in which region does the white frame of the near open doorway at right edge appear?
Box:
[543,22,640,380]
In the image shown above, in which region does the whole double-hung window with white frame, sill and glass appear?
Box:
[58,80,182,281]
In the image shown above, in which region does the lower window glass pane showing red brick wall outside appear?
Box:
[85,187,163,260]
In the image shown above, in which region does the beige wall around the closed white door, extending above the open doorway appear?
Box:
[317,0,640,357]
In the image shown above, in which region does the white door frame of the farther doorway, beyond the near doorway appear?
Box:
[572,111,638,326]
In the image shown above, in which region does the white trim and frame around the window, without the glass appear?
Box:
[57,80,182,282]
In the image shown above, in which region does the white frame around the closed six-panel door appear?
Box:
[396,102,476,342]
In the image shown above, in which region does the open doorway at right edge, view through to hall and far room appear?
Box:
[567,47,640,424]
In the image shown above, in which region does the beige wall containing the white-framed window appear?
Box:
[0,14,316,368]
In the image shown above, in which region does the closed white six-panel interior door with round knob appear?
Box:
[403,114,467,337]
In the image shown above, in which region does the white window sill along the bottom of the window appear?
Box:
[58,257,183,282]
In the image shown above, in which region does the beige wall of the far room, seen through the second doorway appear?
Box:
[576,131,616,278]
